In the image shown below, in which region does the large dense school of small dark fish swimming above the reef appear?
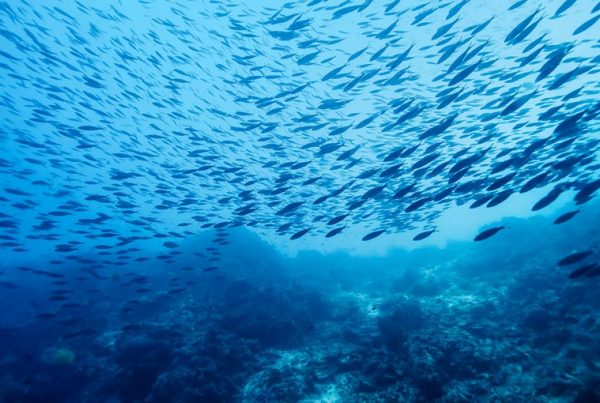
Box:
[0,0,600,280]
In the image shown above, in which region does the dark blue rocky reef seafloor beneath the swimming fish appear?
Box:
[0,213,600,403]
